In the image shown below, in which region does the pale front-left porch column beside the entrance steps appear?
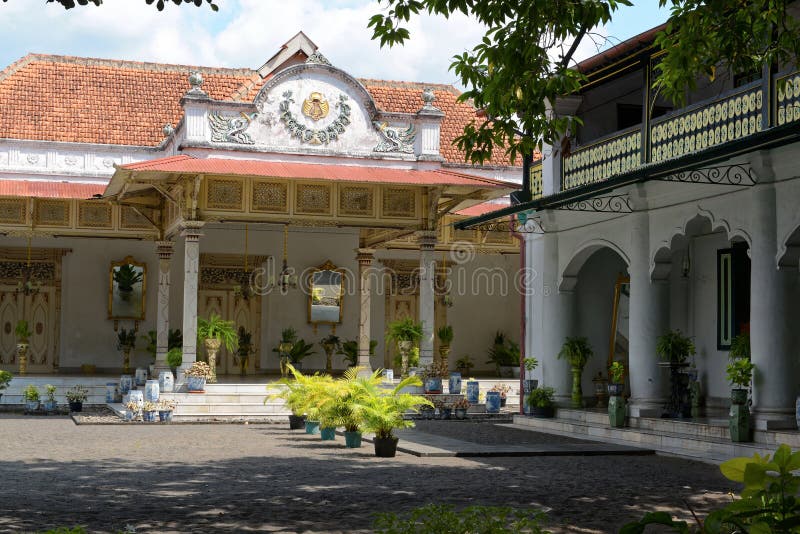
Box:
[181,221,205,378]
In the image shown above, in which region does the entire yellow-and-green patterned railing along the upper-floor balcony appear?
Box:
[560,71,800,193]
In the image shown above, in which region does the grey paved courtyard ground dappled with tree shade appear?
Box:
[0,415,732,533]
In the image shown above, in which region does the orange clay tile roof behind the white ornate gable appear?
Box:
[0,54,520,165]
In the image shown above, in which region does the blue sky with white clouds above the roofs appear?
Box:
[0,0,668,83]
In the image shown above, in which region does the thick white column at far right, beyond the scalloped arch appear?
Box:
[750,182,797,429]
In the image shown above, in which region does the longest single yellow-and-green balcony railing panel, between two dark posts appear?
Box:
[650,81,764,163]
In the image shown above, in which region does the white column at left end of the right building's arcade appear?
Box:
[534,232,575,404]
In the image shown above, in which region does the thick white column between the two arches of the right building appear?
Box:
[628,210,669,417]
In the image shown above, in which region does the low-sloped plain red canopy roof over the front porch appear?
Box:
[120,154,516,189]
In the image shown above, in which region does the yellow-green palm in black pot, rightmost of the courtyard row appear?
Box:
[356,376,433,458]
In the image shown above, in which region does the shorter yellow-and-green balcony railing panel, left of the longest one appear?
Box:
[562,128,642,189]
